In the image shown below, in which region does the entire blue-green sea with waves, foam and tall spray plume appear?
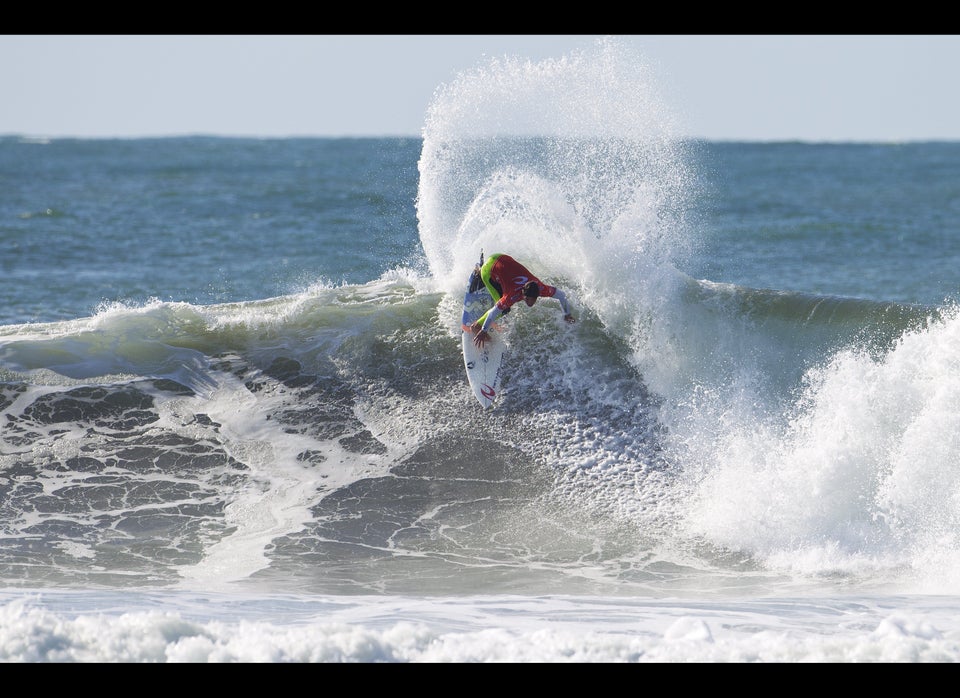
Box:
[0,43,960,663]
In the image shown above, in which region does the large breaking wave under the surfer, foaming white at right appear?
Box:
[0,266,960,591]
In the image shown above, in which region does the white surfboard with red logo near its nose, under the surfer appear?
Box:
[460,254,506,409]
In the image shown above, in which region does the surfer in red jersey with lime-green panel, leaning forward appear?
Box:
[471,253,576,349]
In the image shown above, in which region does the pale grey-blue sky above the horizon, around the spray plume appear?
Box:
[0,34,960,142]
